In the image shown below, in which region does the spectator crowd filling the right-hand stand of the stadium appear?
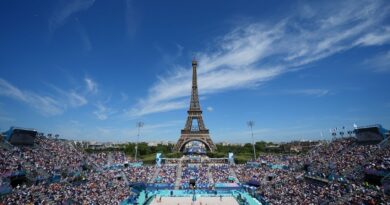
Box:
[235,138,390,204]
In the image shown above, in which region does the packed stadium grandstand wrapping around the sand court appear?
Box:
[0,128,390,205]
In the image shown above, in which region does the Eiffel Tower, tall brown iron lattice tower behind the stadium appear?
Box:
[175,60,216,152]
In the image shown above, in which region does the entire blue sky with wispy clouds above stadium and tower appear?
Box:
[0,0,390,142]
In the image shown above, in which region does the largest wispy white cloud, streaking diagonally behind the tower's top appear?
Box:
[130,1,390,116]
